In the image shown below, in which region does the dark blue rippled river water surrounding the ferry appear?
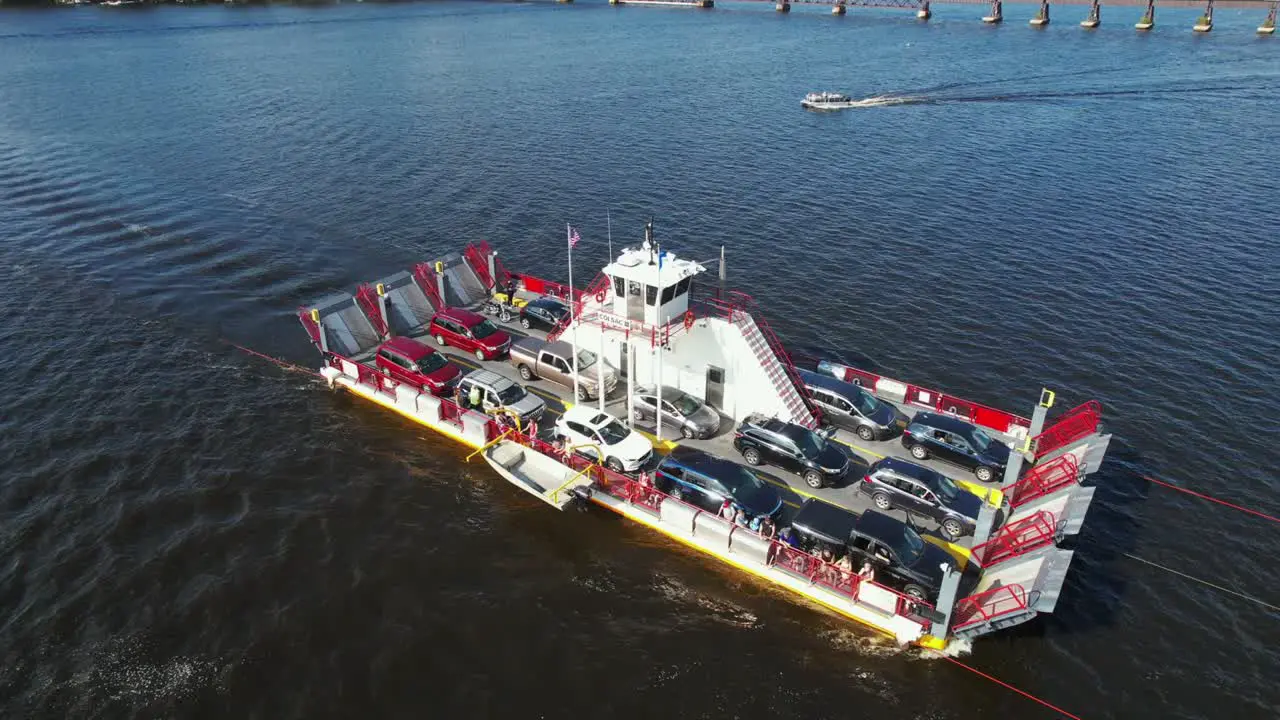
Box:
[0,3,1280,720]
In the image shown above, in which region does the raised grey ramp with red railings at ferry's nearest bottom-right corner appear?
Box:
[951,547,1074,638]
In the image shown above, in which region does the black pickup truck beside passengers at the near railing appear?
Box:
[791,498,956,602]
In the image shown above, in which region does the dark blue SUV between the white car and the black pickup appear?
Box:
[654,446,782,518]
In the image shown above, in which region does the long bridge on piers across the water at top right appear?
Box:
[601,0,1280,35]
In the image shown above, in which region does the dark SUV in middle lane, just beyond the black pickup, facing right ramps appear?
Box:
[858,457,982,541]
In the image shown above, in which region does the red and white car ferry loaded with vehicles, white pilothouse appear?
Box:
[298,224,1110,650]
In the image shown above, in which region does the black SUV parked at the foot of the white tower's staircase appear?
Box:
[733,414,849,488]
